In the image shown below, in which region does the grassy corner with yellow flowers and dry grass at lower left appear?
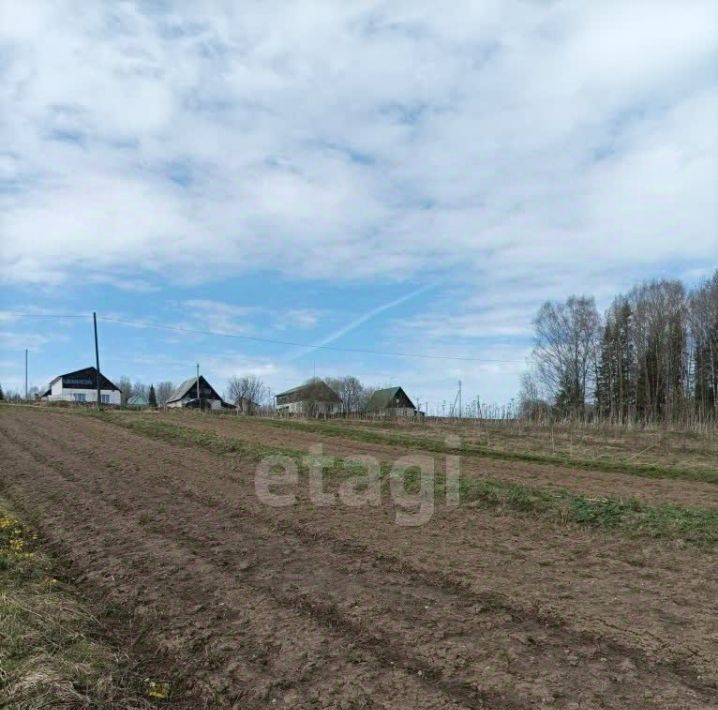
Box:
[0,501,152,710]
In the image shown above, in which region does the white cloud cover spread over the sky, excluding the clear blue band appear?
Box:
[0,0,718,356]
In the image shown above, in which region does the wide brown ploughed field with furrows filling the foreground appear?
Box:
[0,410,718,708]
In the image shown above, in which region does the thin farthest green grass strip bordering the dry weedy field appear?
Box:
[243,417,718,484]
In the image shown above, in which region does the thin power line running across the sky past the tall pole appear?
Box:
[2,312,524,363]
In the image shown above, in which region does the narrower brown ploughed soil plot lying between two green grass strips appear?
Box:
[163,413,718,509]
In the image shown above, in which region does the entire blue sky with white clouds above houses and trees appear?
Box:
[0,0,718,412]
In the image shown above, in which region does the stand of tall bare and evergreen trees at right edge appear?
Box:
[519,270,718,423]
